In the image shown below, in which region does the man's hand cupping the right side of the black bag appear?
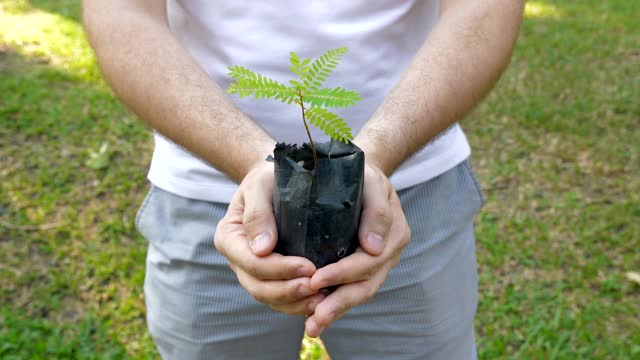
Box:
[305,164,411,337]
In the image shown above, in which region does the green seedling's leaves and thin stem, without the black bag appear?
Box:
[227,47,360,167]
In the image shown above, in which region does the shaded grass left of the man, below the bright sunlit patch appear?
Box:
[0,44,154,359]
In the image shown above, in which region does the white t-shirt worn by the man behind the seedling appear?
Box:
[149,0,470,203]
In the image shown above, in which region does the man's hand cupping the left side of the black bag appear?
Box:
[214,162,324,315]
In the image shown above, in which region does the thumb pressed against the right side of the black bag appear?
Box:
[358,167,393,256]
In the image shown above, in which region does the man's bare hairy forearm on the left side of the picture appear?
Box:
[84,0,275,181]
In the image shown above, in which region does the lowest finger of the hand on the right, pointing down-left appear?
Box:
[305,269,388,337]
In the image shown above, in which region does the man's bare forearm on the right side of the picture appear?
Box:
[355,0,524,175]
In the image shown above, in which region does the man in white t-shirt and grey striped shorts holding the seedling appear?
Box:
[84,0,523,359]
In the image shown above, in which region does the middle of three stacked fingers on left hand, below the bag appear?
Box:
[236,269,318,305]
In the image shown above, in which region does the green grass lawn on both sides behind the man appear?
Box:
[0,0,640,359]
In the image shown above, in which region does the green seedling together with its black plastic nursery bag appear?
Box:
[227,48,365,268]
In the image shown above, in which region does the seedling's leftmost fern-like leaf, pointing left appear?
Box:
[227,66,296,103]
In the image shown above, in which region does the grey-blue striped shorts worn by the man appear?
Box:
[136,161,483,360]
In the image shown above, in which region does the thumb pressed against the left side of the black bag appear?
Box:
[242,166,278,256]
